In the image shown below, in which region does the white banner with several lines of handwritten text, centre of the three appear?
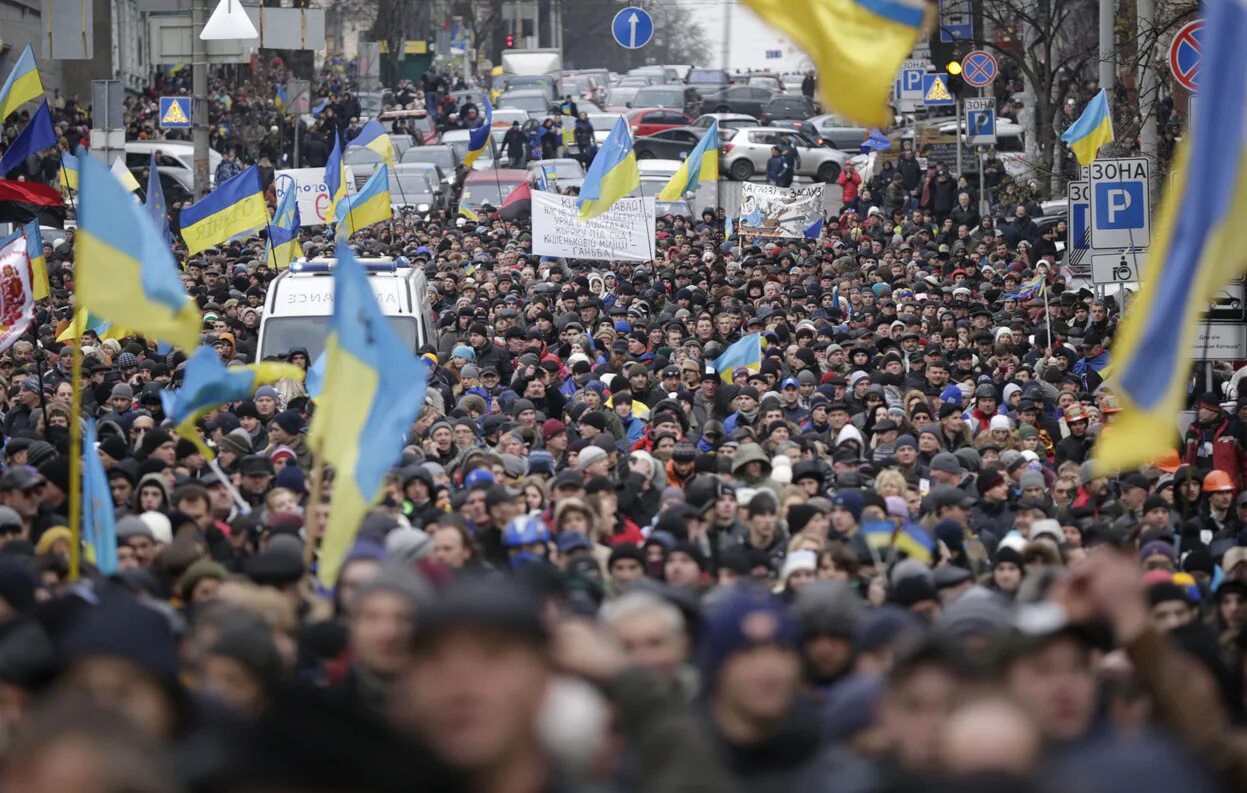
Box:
[532,191,653,262]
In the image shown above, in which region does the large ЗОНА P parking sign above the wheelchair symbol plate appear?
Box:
[1087,157,1152,249]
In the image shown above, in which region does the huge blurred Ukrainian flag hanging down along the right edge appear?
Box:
[1095,0,1247,471]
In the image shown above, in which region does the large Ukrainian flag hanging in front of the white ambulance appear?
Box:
[308,241,429,587]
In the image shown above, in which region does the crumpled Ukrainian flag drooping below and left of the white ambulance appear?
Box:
[160,347,303,460]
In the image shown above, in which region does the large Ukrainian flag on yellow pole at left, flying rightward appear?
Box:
[74,157,200,349]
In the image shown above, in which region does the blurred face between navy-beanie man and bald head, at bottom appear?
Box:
[879,665,959,773]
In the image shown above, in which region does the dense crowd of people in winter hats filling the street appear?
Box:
[0,60,1247,793]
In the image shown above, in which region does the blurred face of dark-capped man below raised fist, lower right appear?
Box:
[1005,637,1095,742]
